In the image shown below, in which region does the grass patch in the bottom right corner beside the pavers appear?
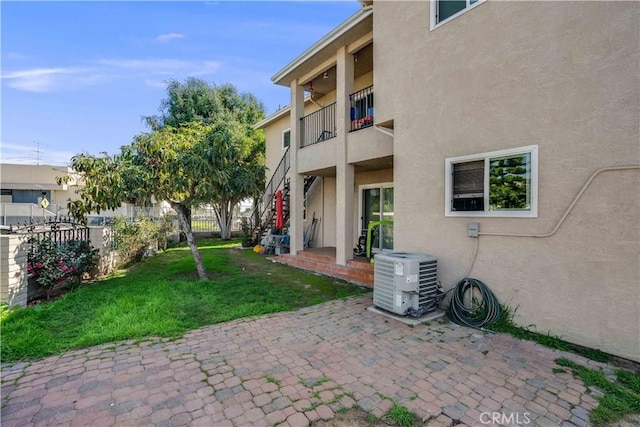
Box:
[556,358,640,426]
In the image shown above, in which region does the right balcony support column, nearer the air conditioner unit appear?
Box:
[336,47,355,265]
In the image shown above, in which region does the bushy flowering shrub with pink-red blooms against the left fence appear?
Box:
[27,237,98,298]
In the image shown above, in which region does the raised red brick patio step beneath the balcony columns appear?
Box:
[270,247,373,288]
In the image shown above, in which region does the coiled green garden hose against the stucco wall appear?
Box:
[447,277,502,329]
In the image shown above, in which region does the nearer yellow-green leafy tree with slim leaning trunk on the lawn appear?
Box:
[59,122,218,280]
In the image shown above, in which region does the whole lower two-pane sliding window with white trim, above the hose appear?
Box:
[445,145,538,218]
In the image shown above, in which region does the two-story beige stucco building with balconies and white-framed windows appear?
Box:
[258,1,640,361]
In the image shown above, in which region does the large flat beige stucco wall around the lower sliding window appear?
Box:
[374,1,640,361]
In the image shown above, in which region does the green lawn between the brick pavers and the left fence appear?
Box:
[0,239,368,362]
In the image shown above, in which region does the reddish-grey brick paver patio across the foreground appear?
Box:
[1,296,604,427]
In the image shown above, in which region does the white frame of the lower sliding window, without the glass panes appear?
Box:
[444,145,538,218]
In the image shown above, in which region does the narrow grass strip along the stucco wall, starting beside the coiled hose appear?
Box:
[491,306,610,363]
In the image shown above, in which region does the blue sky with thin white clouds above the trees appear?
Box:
[0,0,360,164]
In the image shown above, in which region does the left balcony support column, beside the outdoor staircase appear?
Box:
[289,80,304,255]
